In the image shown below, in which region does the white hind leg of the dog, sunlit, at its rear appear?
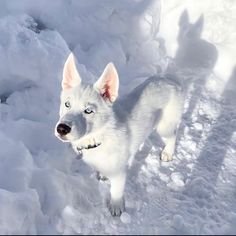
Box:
[156,93,182,161]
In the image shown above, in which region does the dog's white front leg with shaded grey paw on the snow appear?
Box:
[108,173,126,216]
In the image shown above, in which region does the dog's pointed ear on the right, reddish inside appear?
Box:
[93,62,119,103]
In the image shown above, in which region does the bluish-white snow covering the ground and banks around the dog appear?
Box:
[0,0,236,234]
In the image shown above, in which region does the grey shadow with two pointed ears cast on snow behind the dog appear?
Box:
[174,10,218,121]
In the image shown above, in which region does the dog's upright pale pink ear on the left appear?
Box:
[61,53,81,90]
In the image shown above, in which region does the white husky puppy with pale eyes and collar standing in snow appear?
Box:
[55,53,183,216]
